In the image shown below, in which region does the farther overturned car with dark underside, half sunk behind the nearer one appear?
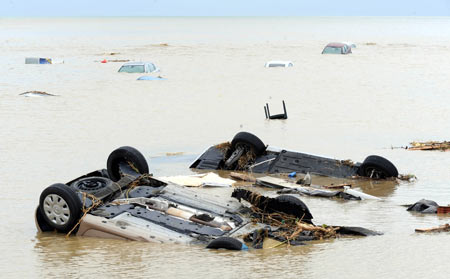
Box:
[190,132,398,179]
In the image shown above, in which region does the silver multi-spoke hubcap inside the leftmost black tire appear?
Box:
[43,194,70,225]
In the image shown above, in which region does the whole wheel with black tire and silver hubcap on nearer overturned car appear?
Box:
[39,183,83,233]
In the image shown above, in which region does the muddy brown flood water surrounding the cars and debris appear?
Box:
[0,17,450,278]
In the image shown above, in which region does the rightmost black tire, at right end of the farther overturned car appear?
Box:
[359,155,398,179]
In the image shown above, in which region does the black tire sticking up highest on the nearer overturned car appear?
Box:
[106,146,148,181]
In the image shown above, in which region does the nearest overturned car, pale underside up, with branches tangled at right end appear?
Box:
[35,146,384,250]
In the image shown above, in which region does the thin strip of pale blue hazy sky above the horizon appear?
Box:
[0,0,450,16]
